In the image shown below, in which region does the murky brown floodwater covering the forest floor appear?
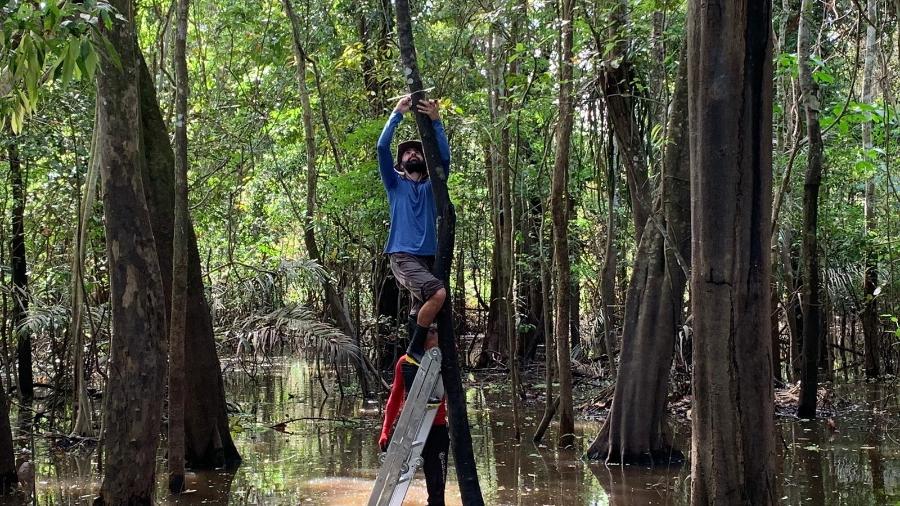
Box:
[17,360,900,506]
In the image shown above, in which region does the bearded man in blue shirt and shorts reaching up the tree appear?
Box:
[378,96,450,389]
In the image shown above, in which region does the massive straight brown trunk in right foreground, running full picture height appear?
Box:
[688,0,777,500]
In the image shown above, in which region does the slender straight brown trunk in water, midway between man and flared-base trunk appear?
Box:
[548,0,575,446]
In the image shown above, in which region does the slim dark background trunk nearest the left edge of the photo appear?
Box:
[6,137,34,402]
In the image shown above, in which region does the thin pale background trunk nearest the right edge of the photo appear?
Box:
[861,0,879,378]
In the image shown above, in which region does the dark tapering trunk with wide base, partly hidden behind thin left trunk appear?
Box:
[138,53,241,469]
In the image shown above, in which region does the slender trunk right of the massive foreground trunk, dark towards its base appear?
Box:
[797,0,824,418]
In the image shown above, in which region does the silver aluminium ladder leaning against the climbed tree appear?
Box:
[369,347,444,506]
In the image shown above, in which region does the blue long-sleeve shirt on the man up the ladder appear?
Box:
[378,111,450,256]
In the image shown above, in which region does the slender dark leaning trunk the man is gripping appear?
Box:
[395,0,484,506]
